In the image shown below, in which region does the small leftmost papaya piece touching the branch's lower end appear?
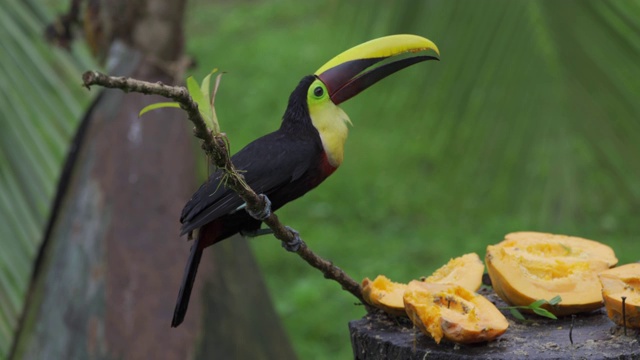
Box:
[362,275,407,316]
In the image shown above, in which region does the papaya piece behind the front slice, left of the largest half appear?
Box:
[421,253,484,292]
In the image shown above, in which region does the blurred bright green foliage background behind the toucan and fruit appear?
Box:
[187,0,640,359]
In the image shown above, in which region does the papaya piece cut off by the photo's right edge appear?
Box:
[598,263,640,328]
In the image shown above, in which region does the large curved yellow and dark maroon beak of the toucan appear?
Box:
[315,35,440,105]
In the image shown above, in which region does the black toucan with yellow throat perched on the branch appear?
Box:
[171,35,440,327]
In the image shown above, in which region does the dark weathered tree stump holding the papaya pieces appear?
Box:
[349,291,640,360]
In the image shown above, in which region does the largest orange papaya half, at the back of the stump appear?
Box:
[485,232,618,315]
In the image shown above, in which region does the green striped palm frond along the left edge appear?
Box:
[0,0,95,357]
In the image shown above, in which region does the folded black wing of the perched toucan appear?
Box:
[180,132,318,235]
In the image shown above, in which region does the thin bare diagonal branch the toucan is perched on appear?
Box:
[82,71,366,304]
